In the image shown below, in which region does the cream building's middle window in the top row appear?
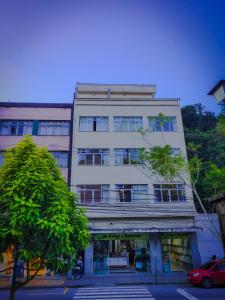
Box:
[114,117,143,131]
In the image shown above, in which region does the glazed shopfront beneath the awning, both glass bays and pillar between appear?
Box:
[85,233,195,274]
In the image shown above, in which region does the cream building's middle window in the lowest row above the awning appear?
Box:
[115,184,148,202]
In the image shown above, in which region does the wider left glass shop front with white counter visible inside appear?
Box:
[93,234,150,273]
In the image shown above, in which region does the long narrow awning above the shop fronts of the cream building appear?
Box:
[90,226,203,234]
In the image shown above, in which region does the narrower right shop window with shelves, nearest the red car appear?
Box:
[161,234,193,272]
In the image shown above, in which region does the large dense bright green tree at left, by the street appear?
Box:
[0,136,89,300]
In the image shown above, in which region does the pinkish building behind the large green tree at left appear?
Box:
[0,102,72,180]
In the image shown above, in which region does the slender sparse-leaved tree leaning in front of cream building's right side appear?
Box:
[139,114,223,242]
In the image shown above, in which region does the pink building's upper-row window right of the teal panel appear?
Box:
[38,121,70,135]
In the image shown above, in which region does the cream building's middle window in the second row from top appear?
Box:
[114,148,141,166]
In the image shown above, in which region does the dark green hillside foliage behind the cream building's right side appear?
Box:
[181,105,225,210]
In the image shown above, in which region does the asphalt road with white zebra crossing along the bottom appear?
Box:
[0,284,225,300]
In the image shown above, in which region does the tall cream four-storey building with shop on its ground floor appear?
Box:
[71,83,222,274]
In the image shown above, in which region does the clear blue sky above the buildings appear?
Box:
[0,0,225,113]
